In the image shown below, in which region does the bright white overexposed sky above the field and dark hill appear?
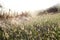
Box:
[0,0,60,11]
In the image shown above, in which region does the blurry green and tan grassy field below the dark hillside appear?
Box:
[0,13,60,40]
